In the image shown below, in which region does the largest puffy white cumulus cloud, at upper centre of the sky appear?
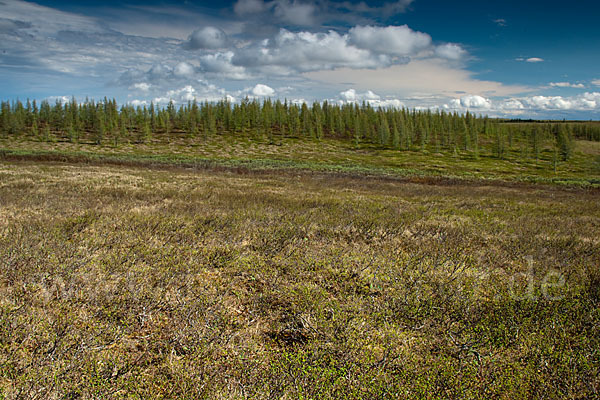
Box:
[231,25,467,76]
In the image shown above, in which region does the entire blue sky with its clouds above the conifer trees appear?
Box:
[0,0,600,120]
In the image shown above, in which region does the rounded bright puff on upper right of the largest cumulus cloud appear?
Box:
[349,25,431,56]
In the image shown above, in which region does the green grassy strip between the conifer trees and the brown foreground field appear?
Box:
[0,135,600,187]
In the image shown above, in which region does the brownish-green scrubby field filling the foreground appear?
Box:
[0,159,600,399]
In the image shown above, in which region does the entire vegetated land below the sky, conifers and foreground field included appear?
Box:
[0,101,600,399]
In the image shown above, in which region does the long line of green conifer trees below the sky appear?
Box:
[0,98,600,162]
